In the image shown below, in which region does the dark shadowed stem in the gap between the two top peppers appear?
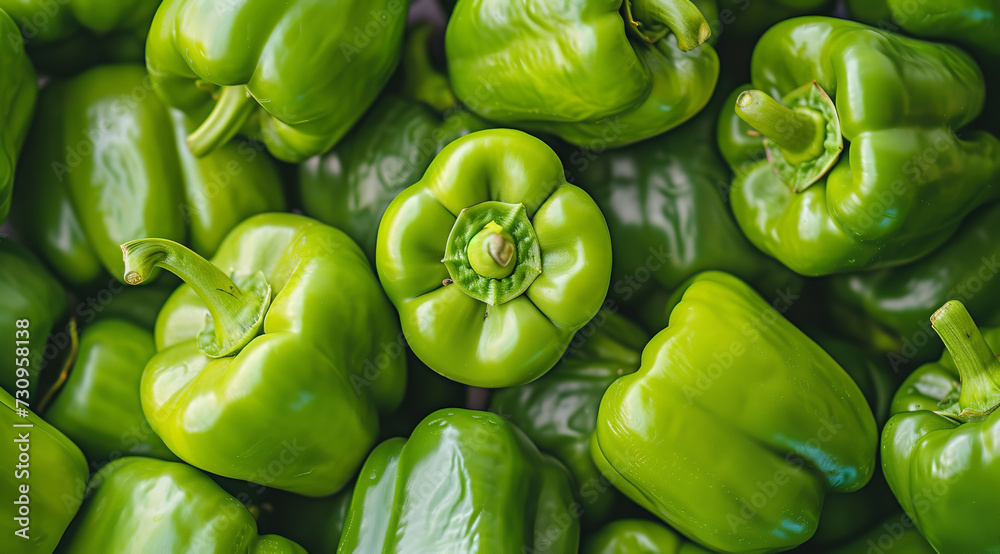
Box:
[400,25,458,113]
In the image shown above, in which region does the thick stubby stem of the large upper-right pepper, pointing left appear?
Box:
[736,90,826,158]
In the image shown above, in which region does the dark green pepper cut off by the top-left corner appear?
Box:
[0,0,160,75]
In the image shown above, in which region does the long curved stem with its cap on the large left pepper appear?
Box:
[122,239,271,358]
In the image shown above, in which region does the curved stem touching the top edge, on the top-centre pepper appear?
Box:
[624,0,712,52]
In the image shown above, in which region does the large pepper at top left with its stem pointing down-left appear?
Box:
[146,0,409,163]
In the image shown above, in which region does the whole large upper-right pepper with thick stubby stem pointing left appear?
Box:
[720,17,1000,276]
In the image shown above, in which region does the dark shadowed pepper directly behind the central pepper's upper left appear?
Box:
[299,94,486,265]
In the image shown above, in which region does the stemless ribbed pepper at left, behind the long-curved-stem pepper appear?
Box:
[17,65,284,287]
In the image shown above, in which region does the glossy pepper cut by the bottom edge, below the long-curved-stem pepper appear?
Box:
[60,457,305,554]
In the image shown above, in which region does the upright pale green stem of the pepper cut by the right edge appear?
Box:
[931,300,1000,416]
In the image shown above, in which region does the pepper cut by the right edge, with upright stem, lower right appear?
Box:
[882,300,1000,552]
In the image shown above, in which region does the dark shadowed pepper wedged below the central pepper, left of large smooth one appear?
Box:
[490,311,649,524]
